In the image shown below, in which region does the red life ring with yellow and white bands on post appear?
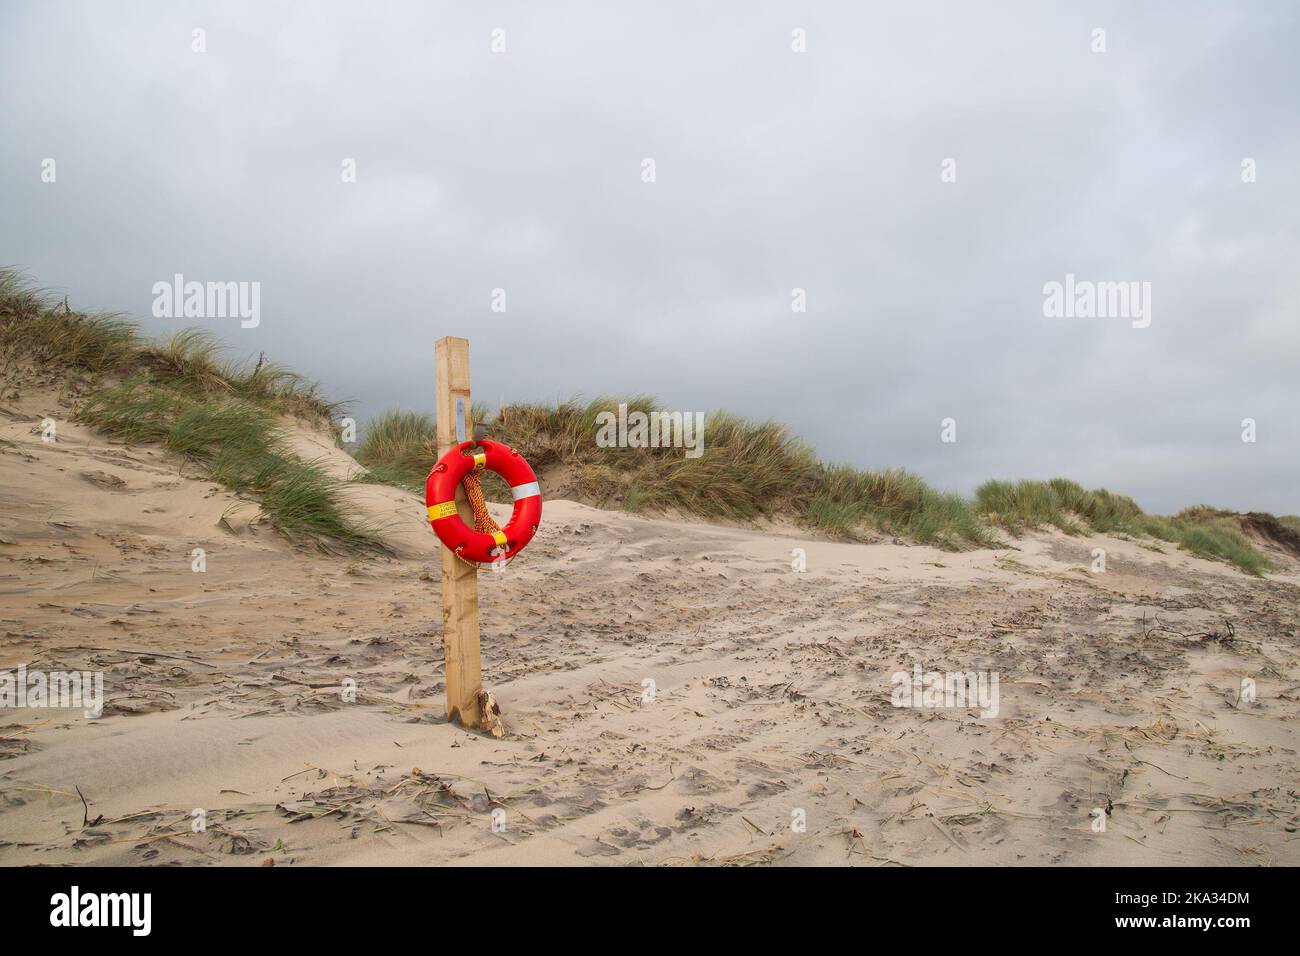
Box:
[424,438,542,564]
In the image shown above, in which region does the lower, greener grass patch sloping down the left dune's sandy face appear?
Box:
[77,372,377,546]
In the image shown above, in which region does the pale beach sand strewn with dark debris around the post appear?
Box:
[0,389,1300,866]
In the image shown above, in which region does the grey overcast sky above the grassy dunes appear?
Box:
[0,0,1300,512]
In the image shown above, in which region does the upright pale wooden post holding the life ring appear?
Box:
[433,336,484,728]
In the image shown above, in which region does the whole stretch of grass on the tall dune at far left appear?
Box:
[0,269,380,548]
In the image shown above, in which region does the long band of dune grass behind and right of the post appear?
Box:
[358,395,1270,575]
